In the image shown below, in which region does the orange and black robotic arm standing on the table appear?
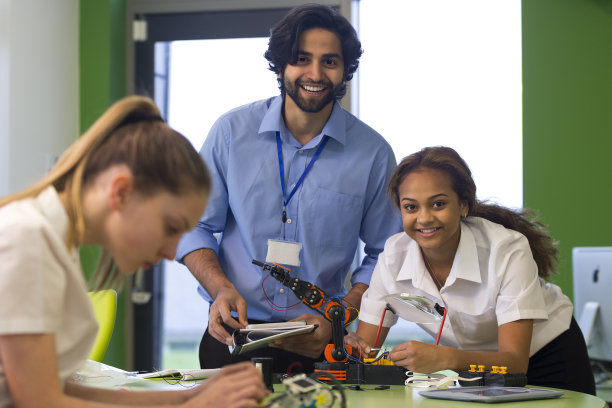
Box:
[252,260,351,362]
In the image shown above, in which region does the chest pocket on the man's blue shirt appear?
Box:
[308,187,362,248]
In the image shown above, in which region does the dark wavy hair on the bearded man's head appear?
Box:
[264,4,363,99]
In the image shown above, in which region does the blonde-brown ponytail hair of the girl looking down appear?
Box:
[0,96,211,288]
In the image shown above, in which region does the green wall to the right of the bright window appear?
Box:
[522,0,612,297]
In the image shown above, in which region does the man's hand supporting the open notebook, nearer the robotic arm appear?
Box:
[270,314,332,358]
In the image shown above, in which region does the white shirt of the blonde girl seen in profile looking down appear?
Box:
[0,187,98,407]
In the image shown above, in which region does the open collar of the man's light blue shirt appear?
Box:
[259,95,346,145]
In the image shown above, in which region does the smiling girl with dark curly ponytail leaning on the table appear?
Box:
[346,147,595,394]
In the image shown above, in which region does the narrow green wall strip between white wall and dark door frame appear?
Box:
[79,0,127,368]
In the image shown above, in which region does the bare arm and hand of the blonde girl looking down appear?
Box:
[0,334,267,408]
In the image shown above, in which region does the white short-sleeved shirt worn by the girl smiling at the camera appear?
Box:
[359,217,572,356]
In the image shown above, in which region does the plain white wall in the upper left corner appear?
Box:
[0,0,79,195]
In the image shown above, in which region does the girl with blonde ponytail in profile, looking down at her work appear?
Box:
[0,96,267,408]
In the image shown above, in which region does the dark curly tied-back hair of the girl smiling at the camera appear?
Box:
[388,146,558,278]
